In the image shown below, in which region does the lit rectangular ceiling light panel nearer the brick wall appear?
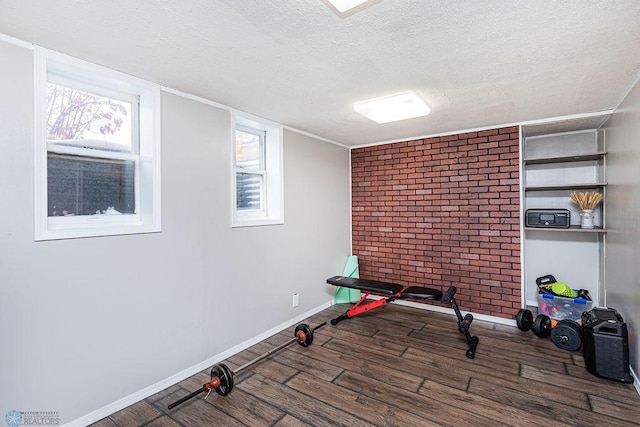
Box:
[353,92,431,124]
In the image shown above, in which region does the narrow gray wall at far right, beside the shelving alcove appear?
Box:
[605,77,640,374]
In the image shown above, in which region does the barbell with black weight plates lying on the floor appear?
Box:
[168,322,327,409]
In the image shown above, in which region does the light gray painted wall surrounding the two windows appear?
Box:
[0,41,350,422]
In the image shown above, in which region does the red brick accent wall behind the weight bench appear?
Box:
[351,127,520,317]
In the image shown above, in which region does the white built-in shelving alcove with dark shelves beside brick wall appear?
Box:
[522,118,607,306]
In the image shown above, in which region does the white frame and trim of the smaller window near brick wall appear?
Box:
[231,111,284,227]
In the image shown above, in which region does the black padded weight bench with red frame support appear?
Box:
[327,276,478,359]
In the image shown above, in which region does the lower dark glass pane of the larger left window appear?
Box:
[47,153,136,217]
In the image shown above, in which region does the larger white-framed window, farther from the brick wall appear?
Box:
[35,48,160,240]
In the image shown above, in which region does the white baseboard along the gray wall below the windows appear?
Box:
[64,301,333,427]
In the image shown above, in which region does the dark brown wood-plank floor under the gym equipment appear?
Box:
[94,304,640,427]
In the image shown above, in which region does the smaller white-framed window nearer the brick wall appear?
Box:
[233,114,283,227]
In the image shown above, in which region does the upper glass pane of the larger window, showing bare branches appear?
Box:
[47,83,137,153]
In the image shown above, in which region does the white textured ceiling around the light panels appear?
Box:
[0,0,640,145]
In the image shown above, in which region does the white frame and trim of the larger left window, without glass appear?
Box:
[34,46,161,241]
